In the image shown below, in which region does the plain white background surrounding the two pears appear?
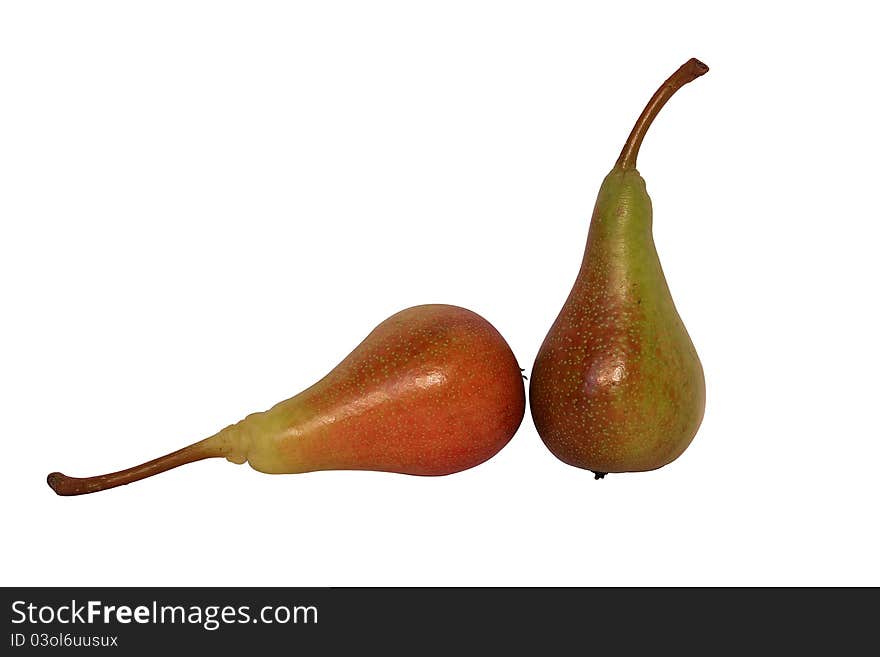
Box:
[0,1,880,586]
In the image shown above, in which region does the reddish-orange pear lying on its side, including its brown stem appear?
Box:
[48,305,525,495]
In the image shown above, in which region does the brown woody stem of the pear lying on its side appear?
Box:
[46,436,225,496]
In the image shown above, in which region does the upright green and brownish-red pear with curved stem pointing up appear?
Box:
[529,59,709,478]
